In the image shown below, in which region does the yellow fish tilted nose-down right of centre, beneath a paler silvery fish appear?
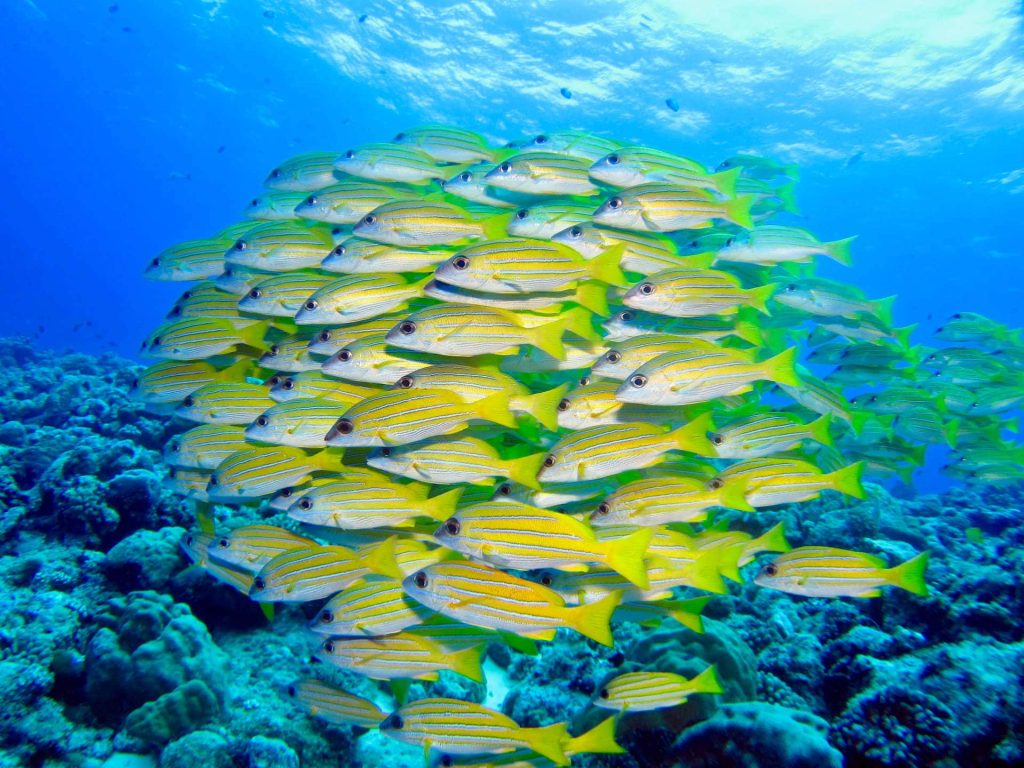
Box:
[538,414,714,483]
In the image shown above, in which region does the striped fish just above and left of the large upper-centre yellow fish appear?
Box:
[352,199,507,248]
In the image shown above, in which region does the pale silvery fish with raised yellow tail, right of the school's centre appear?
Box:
[615,347,800,406]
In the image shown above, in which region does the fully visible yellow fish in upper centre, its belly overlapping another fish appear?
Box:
[434,239,629,294]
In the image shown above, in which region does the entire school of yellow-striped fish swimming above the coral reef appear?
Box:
[134,125,1024,766]
